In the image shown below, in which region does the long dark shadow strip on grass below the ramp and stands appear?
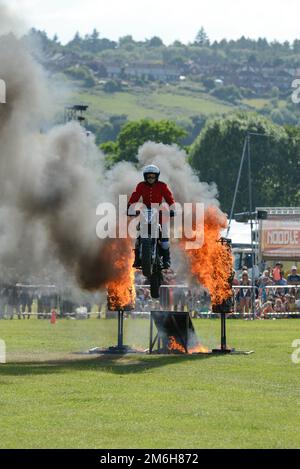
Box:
[0,354,215,376]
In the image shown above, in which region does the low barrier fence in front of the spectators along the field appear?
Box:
[0,284,300,319]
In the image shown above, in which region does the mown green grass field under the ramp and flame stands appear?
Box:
[0,319,300,448]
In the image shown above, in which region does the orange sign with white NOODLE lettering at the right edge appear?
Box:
[261,219,300,260]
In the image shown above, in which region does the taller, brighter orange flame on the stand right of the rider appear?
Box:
[183,206,233,305]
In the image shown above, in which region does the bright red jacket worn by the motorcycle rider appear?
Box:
[128,181,175,208]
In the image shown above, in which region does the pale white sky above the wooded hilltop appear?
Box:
[0,0,300,45]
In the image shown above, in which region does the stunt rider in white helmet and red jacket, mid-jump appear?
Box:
[128,164,175,269]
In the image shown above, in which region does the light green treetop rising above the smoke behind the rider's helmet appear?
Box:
[101,119,186,162]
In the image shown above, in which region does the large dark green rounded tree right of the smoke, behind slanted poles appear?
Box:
[190,113,292,212]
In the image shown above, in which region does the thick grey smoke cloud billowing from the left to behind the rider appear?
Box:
[0,3,224,296]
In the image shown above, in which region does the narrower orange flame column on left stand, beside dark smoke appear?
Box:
[106,239,135,311]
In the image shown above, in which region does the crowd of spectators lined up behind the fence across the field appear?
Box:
[0,262,300,319]
